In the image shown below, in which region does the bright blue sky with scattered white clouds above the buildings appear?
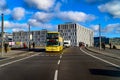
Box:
[0,0,120,37]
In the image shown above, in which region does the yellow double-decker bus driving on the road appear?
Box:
[45,32,63,51]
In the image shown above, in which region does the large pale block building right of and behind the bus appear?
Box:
[58,23,94,46]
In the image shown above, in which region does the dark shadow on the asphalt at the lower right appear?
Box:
[89,69,120,77]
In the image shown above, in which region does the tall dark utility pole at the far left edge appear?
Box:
[1,13,4,56]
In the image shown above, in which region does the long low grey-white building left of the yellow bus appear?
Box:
[13,30,47,46]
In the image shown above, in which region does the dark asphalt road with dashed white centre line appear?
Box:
[0,47,120,80]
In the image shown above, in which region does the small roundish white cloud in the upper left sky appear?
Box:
[12,7,25,20]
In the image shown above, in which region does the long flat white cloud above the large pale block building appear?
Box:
[57,11,95,22]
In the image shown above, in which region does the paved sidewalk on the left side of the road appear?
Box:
[0,49,28,58]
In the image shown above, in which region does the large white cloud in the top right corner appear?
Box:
[98,0,120,18]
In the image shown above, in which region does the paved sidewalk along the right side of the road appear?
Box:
[86,47,120,59]
